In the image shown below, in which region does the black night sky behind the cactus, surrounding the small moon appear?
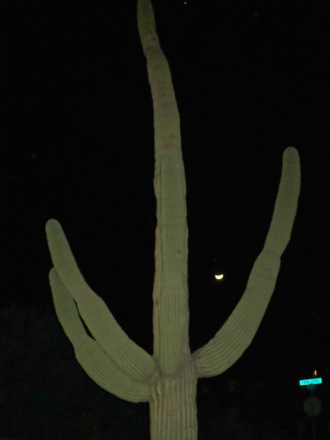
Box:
[0,0,330,434]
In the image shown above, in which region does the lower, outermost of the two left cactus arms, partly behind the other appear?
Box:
[49,268,149,402]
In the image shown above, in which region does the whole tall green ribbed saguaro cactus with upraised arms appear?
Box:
[46,0,300,440]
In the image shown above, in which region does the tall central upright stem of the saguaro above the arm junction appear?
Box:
[138,0,190,375]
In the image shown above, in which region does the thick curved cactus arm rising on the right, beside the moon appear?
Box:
[193,147,300,377]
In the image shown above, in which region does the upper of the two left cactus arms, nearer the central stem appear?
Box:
[46,219,155,380]
